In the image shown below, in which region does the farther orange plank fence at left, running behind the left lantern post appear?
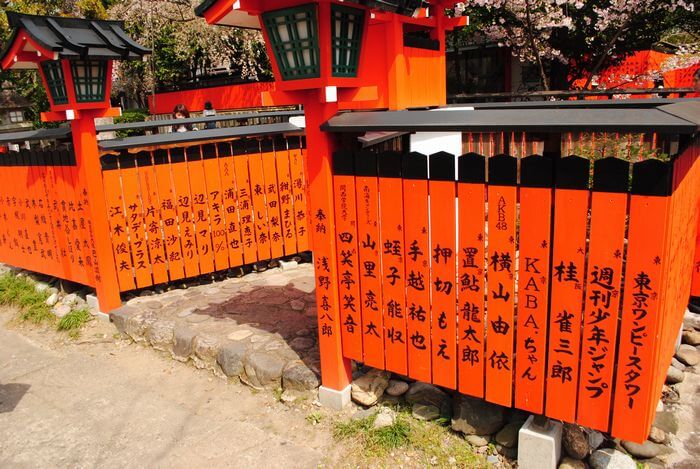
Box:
[0,135,309,291]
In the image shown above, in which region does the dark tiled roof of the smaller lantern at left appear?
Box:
[0,11,151,69]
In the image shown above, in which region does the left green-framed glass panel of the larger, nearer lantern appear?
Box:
[262,4,320,80]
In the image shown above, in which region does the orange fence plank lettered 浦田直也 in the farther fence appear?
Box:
[217,142,244,267]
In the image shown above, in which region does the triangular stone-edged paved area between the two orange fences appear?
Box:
[112,264,320,393]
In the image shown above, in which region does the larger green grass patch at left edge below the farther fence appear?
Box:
[0,272,54,324]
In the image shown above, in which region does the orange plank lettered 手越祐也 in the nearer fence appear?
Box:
[403,153,432,382]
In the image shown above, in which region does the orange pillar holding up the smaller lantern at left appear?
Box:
[71,111,121,313]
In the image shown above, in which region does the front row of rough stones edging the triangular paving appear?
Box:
[110,305,319,392]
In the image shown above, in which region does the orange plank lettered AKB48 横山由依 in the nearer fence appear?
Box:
[485,181,517,406]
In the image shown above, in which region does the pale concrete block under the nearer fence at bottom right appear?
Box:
[518,415,562,469]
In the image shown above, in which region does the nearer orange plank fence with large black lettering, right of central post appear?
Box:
[333,134,700,441]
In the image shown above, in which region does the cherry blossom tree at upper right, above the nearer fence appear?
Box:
[455,0,698,90]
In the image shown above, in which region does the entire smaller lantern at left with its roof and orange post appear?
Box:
[0,12,150,313]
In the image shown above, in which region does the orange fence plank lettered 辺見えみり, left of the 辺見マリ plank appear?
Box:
[169,148,199,277]
